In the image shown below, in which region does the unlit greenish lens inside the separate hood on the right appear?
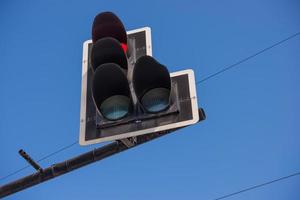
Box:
[141,88,170,113]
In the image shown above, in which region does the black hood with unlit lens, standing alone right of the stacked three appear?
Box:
[132,56,171,113]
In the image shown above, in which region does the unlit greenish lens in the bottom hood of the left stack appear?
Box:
[100,95,130,120]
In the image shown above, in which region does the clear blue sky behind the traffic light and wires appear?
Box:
[0,0,300,200]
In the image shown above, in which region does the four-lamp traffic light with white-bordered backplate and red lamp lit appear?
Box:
[80,12,203,145]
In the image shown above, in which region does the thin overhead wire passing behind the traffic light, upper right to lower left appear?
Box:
[0,32,300,184]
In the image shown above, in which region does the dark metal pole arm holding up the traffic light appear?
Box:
[0,109,205,198]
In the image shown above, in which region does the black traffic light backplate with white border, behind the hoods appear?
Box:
[79,27,199,145]
